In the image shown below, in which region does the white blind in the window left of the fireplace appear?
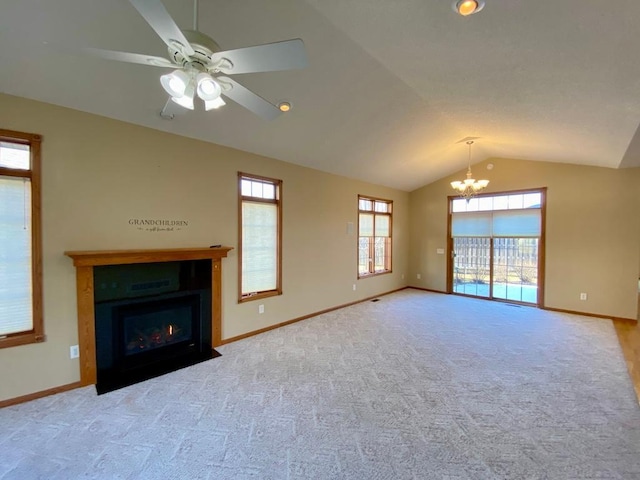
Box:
[0,176,33,335]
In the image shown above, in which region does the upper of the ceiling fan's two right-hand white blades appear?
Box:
[211,38,308,75]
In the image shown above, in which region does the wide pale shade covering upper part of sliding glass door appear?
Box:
[451,208,542,237]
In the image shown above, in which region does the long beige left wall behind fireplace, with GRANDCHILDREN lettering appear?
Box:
[0,95,409,400]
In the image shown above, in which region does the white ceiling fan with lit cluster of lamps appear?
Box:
[83,0,307,120]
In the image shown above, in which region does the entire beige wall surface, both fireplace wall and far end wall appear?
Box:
[0,94,640,400]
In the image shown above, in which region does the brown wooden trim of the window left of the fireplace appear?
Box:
[0,129,45,348]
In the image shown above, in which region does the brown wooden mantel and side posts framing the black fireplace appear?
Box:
[64,246,233,385]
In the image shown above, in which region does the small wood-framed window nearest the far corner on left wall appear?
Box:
[358,195,393,278]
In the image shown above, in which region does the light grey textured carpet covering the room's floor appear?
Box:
[0,290,640,480]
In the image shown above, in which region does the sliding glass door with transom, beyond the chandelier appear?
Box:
[450,190,545,305]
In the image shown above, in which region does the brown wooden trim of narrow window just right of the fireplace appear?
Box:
[238,172,282,303]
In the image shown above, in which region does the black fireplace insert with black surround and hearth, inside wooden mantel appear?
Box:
[94,260,217,393]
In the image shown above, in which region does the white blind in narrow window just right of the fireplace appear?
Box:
[241,200,278,295]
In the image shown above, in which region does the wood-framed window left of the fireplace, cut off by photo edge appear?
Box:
[0,130,44,347]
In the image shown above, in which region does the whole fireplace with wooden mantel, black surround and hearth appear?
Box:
[65,247,231,393]
